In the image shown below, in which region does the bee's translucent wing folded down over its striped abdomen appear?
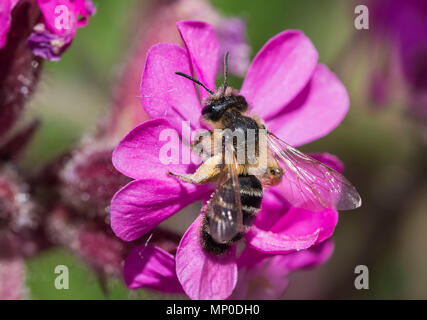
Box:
[206,143,243,243]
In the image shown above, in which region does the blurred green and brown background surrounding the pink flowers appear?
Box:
[22,0,427,299]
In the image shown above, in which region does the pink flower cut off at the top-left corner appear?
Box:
[0,0,96,60]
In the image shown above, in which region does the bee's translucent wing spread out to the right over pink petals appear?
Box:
[268,132,362,211]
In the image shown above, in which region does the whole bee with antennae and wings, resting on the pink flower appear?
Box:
[170,53,361,255]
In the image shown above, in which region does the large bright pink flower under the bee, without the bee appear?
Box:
[110,21,349,299]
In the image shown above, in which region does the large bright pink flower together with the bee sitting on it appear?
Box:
[110,21,360,299]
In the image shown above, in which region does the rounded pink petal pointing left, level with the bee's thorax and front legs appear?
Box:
[113,119,196,179]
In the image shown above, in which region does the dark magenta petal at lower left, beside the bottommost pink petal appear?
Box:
[123,244,183,293]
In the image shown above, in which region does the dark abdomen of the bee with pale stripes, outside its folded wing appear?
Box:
[201,175,263,255]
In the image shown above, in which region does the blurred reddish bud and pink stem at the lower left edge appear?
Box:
[0,165,46,300]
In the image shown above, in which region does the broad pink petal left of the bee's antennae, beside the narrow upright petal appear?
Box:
[141,43,200,131]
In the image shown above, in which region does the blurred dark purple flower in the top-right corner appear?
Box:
[369,0,427,131]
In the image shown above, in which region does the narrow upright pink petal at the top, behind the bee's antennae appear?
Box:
[177,21,219,100]
